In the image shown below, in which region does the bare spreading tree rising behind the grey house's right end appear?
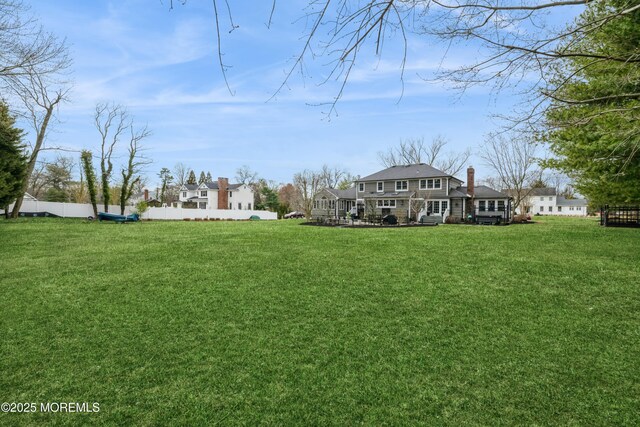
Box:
[479,134,542,213]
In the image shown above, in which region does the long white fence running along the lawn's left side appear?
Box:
[9,200,278,220]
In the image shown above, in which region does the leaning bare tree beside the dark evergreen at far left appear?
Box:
[9,71,70,218]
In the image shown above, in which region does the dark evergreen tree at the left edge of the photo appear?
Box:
[0,101,27,217]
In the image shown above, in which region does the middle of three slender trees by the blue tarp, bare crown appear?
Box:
[94,103,131,212]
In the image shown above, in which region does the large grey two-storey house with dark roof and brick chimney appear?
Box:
[311,163,511,222]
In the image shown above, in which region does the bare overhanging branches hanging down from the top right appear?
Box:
[192,0,640,120]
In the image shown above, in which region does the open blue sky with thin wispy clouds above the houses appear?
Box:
[25,0,556,184]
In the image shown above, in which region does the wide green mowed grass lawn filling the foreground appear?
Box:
[0,218,640,426]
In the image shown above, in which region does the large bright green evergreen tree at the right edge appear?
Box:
[544,0,640,206]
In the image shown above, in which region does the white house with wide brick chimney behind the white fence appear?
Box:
[176,178,254,210]
